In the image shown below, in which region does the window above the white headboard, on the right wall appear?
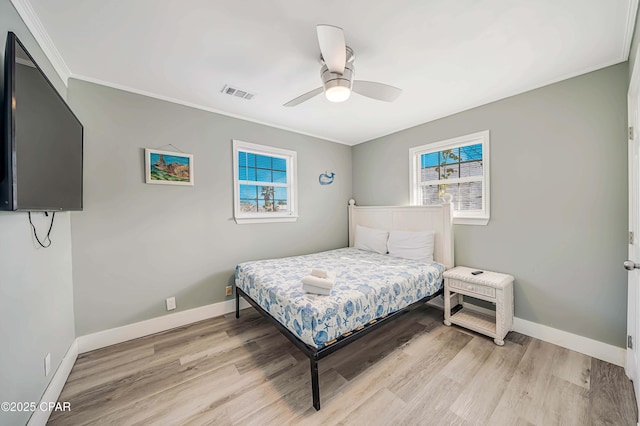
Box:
[409,130,490,225]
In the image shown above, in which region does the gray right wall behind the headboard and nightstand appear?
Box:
[353,63,628,347]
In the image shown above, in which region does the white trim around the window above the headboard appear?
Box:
[409,130,491,225]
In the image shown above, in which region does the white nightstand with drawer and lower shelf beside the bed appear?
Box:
[442,266,513,346]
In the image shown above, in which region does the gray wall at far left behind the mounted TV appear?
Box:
[0,0,75,425]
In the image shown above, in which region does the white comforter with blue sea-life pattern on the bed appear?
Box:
[236,248,445,348]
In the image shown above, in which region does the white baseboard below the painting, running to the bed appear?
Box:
[76,298,251,354]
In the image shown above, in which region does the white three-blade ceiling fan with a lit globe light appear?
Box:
[284,25,402,107]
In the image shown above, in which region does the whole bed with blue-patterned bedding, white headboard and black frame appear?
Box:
[235,200,454,410]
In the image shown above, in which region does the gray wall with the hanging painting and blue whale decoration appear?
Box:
[68,80,352,336]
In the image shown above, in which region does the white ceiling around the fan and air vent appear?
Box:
[12,0,638,145]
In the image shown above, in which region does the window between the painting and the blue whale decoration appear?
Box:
[233,140,298,223]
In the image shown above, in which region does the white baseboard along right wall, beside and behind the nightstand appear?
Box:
[463,303,627,367]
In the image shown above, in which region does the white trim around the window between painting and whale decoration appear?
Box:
[233,139,298,224]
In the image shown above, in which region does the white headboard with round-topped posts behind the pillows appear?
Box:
[349,200,454,269]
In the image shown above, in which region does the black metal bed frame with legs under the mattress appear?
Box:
[236,287,443,410]
